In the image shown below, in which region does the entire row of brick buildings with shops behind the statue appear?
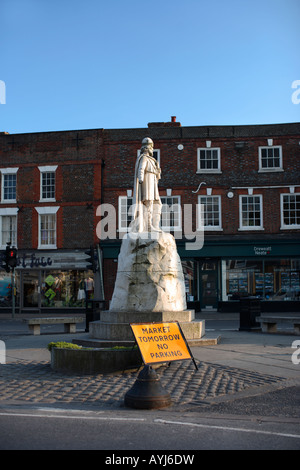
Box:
[0,118,300,311]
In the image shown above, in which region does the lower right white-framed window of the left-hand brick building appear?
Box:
[35,207,59,249]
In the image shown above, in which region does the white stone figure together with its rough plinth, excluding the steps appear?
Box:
[110,137,186,312]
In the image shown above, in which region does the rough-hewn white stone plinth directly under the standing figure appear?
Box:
[110,232,186,312]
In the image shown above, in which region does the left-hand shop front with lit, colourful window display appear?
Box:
[0,250,95,313]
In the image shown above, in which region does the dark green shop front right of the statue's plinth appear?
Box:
[178,240,300,312]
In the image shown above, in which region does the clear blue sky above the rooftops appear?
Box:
[0,0,300,133]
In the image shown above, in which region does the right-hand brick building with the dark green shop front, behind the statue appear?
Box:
[101,118,300,311]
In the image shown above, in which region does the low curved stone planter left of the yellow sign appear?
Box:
[51,347,142,375]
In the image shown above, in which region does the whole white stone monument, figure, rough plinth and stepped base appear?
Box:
[90,137,204,344]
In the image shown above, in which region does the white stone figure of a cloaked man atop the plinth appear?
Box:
[132,137,162,232]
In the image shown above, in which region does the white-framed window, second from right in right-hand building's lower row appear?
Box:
[239,195,263,230]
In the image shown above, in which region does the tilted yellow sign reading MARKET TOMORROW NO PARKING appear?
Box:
[130,322,193,364]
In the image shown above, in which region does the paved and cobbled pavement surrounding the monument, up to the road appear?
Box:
[0,314,300,418]
